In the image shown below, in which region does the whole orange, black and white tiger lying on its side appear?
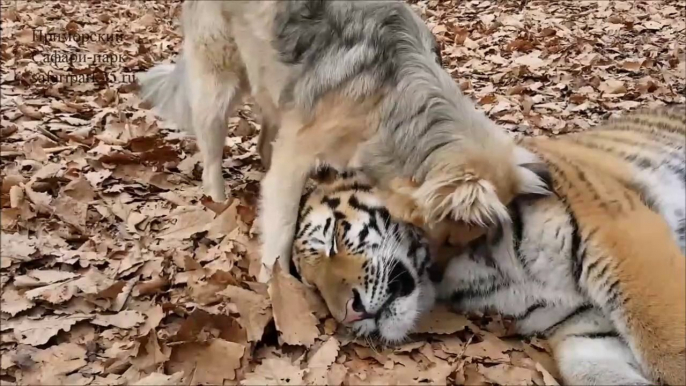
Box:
[293,106,686,385]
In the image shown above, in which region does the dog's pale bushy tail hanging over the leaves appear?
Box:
[137,54,191,131]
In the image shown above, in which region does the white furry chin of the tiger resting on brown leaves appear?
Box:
[350,282,436,345]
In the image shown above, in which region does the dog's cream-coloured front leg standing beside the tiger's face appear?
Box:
[258,116,316,283]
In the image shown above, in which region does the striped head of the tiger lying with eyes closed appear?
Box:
[292,167,435,343]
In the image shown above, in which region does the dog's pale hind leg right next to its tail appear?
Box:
[189,61,242,202]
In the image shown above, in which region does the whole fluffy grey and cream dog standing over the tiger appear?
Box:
[139,0,544,280]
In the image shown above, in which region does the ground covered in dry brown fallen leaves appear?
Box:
[0,0,686,385]
